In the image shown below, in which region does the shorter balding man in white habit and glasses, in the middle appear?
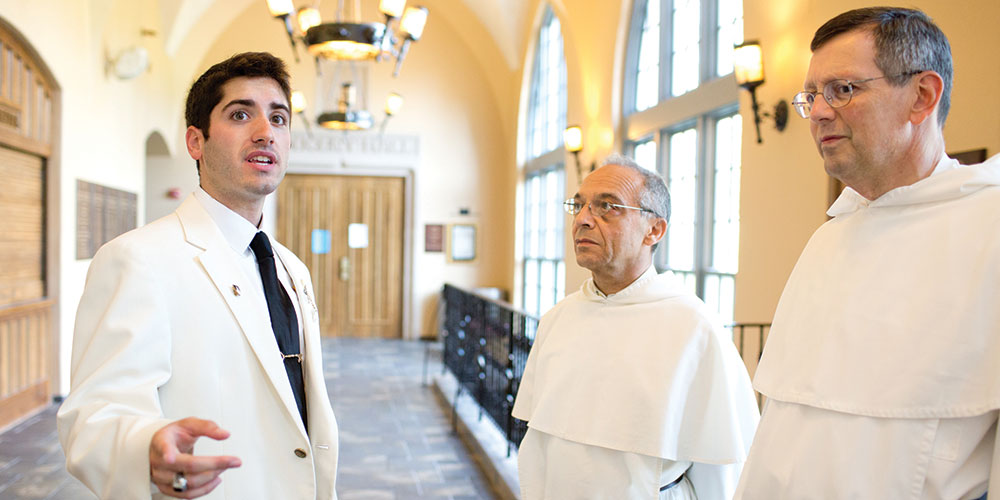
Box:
[513,155,759,500]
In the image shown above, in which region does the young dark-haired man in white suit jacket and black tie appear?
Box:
[58,53,338,500]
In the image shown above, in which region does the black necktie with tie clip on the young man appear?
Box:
[250,231,309,431]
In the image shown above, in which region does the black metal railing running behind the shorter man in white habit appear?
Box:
[442,284,771,456]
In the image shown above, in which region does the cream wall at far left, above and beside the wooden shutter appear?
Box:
[0,0,183,393]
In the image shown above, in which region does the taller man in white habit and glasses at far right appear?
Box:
[736,8,1000,500]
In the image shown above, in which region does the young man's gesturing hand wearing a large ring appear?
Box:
[149,417,242,498]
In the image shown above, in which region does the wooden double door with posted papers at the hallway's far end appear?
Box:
[277,174,404,338]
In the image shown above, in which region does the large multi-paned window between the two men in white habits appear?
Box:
[624,0,743,321]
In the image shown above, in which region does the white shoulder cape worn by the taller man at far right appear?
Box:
[754,156,1000,418]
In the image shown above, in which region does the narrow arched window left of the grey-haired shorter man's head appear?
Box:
[521,7,566,315]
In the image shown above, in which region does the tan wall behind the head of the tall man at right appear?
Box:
[736,0,1000,328]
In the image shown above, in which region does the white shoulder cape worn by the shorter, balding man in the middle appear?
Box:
[513,271,759,465]
